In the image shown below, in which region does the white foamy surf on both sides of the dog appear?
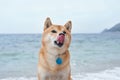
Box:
[0,67,120,80]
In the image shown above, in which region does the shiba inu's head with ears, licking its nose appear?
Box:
[42,18,72,53]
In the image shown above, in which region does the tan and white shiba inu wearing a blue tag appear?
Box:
[38,17,72,80]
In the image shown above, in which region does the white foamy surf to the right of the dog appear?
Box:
[73,67,120,80]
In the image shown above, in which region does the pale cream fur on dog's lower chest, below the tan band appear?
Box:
[38,66,70,80]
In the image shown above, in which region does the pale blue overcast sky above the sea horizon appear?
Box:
[0,0,120,34]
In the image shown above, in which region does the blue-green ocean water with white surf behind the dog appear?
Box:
[0,33,120,80]
